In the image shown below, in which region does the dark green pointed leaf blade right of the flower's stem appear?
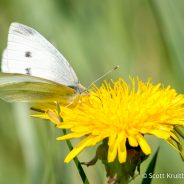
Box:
[142,148,159,184]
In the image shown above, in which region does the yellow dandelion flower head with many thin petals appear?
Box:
[35,79,184,163]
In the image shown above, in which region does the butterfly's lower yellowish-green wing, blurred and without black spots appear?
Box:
[0,73,76,104]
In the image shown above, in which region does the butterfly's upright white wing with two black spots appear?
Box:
[1,23,79,88]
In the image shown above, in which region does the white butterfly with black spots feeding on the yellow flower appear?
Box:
[0,23,85,104]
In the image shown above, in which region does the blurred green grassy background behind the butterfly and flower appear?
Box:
[0,0,184,184]
